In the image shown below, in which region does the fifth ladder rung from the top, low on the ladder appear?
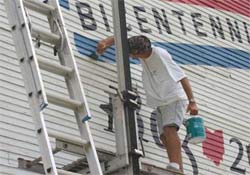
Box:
[48,131,89,146]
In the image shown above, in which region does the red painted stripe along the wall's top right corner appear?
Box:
[162,0,250,17]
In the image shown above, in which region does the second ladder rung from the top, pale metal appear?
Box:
[31,26,60,45]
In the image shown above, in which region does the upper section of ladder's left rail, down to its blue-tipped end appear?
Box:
[4,0,48,110]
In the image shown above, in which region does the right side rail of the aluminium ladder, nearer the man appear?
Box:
[45,1,102,175]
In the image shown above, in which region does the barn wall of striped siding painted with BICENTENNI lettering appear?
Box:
[0,0,250,175]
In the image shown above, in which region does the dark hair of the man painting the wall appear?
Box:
[128,35,151,54]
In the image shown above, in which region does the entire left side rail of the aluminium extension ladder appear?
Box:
[4,0,57,175]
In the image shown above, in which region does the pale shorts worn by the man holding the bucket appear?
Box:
[156,100,187,135]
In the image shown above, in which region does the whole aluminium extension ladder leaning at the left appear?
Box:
[5,0,103,175]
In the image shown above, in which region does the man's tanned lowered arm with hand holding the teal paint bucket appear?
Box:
[180,77,198,115]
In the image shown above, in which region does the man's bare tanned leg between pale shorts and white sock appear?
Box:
[161,126,183,172]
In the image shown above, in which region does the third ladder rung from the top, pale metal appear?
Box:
[37,57,73,76]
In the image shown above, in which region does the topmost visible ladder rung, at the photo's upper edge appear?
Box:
[24,0,56,16]
